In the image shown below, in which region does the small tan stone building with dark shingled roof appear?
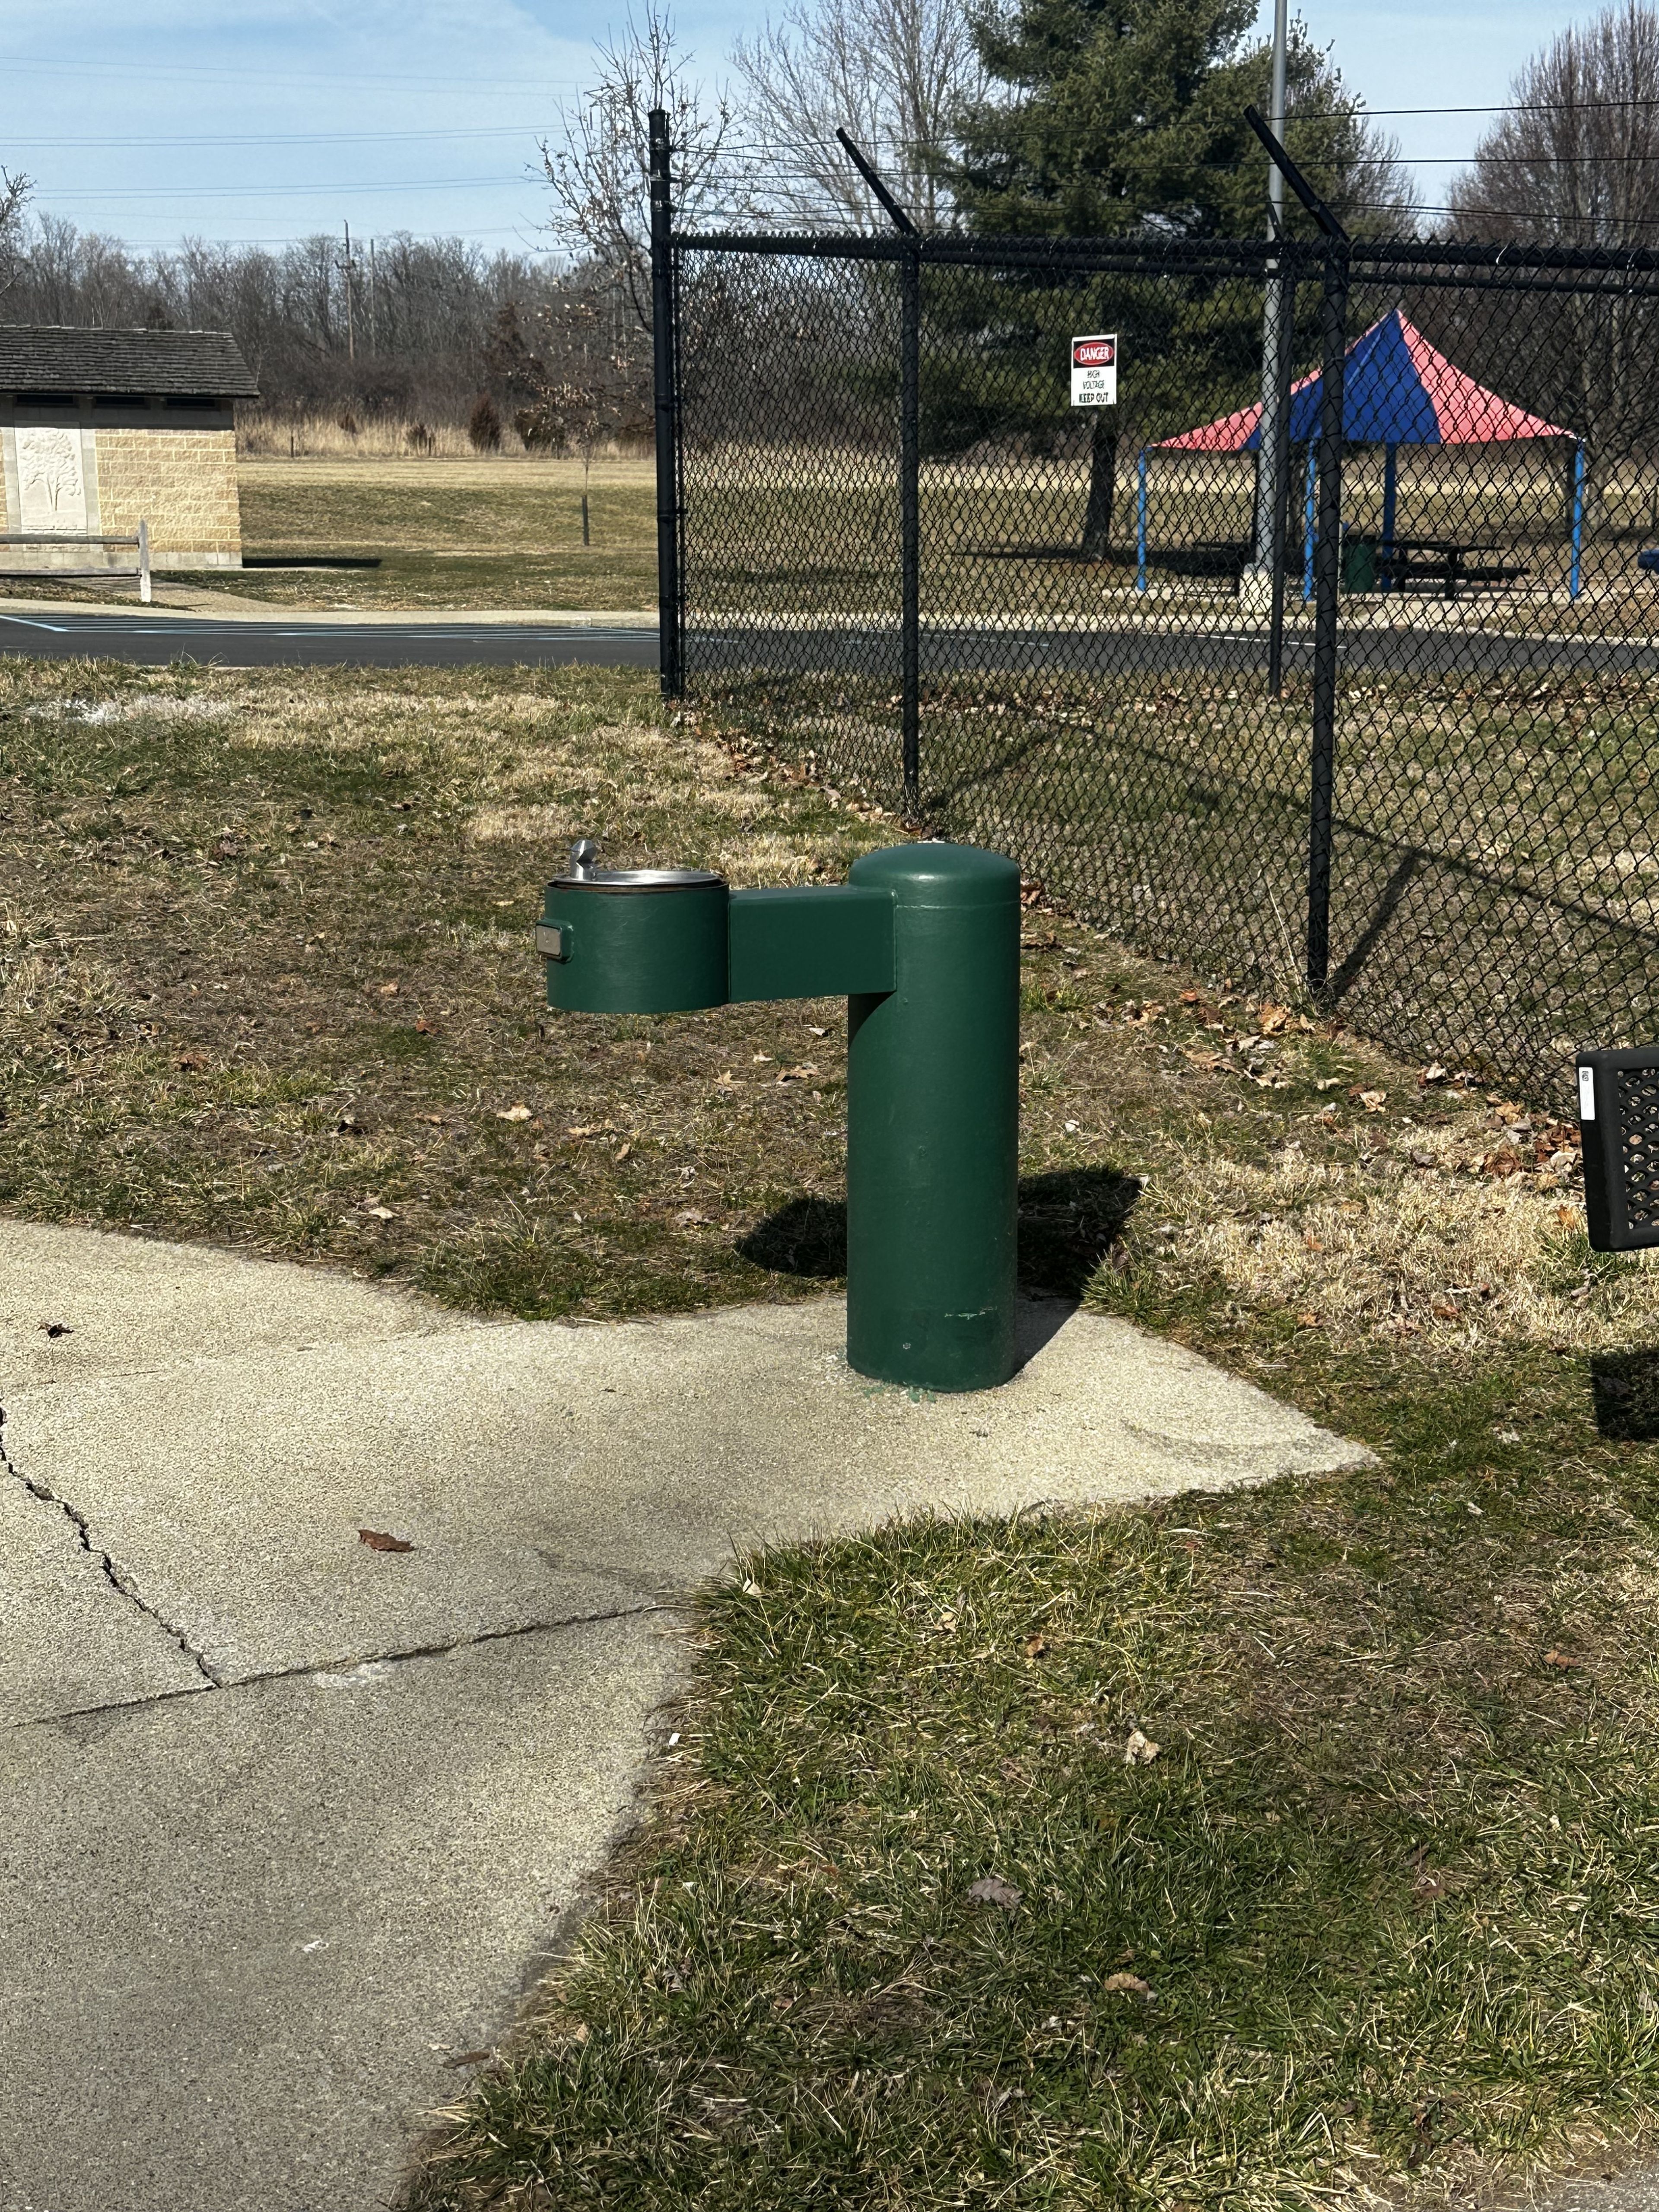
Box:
[0,323,259,571]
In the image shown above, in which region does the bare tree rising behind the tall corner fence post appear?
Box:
[542,0,734,330]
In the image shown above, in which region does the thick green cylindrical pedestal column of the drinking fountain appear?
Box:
[847,845,1020,1391]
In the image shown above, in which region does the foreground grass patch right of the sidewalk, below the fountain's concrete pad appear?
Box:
[413,1268,1659,2212]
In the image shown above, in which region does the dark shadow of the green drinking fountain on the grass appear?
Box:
[737,1168,1139,1298]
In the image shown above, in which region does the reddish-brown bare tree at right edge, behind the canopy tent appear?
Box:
[1449,0,1659,522]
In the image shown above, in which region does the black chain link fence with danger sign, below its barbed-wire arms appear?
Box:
[664,235,1659,1108]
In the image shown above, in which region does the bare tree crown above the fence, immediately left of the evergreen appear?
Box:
[734,0,984,230]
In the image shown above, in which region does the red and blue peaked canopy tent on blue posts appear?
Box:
[1135,308,1584,600]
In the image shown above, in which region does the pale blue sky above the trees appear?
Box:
[0,0,1628,248]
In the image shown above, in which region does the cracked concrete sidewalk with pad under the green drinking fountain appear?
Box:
[0,1221,1363,2212]
